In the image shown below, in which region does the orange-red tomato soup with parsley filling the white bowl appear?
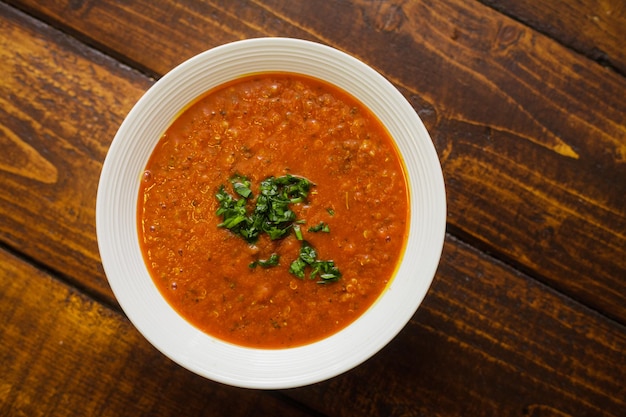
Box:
[138,73,409,349]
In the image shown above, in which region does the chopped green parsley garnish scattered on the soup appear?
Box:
[215,174,341,284]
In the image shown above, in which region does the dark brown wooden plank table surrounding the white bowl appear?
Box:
[0,0,626,417]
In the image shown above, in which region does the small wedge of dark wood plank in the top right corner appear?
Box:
[480,0,626,75]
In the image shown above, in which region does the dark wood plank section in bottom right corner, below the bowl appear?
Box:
[290,238,626,417]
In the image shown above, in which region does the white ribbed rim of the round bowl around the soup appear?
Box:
[96,38,446,389]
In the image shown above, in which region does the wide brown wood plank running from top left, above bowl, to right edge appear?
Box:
[4,0,626,323]
